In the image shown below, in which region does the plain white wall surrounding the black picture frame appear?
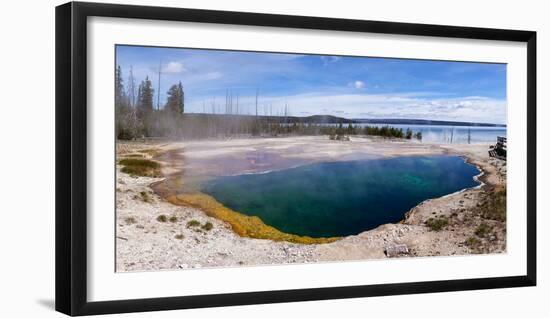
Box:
[0,0,550,318]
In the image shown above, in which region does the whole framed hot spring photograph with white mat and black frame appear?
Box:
[56,2,536,315]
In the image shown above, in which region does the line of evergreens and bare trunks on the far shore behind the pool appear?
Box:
[115,66,422,140]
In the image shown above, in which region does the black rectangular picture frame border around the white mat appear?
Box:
[55,2,536,316]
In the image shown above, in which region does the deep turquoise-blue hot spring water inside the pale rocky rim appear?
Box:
[203,156,479,237]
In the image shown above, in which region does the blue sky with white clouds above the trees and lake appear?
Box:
[116,46,506,124]
